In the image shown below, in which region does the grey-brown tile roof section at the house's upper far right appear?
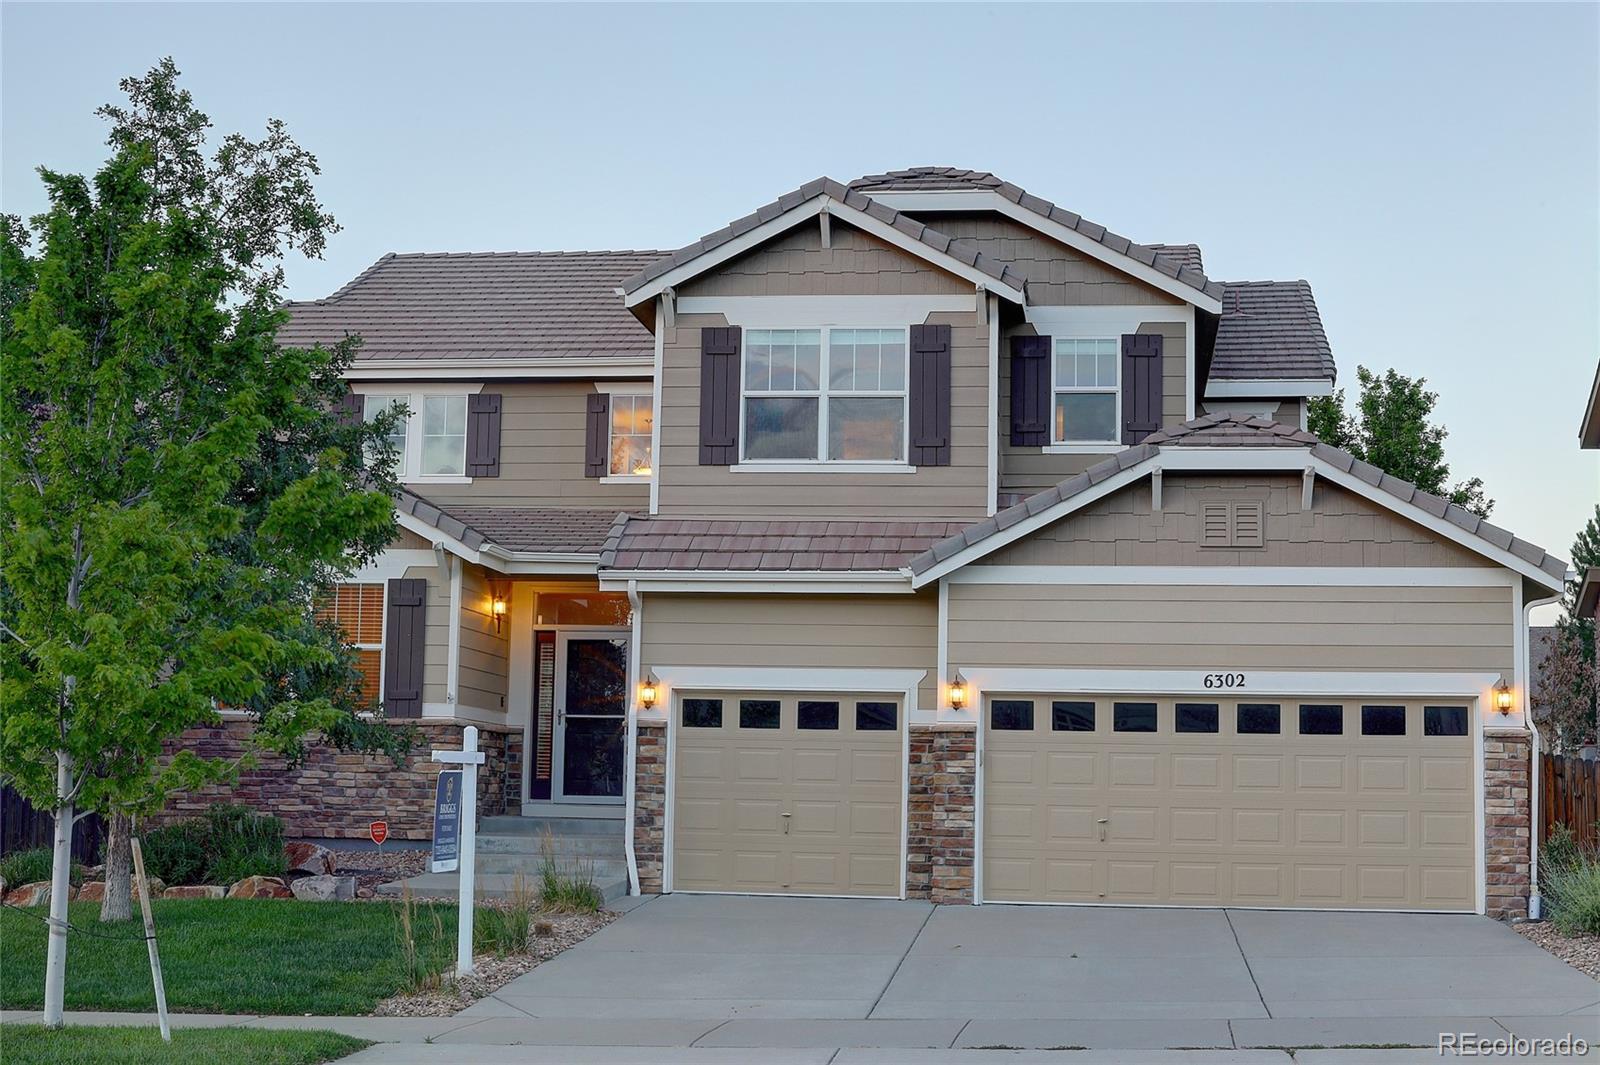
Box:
[1210,281,1338,381]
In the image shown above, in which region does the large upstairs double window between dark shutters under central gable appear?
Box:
[739,328,906,462]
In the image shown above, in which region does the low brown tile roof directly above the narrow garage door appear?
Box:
[600,518,965,572]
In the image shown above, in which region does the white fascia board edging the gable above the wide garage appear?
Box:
[912,446,1563,593]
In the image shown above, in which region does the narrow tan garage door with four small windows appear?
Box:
[672,692,904,897]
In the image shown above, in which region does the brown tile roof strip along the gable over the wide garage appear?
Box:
[907,414,1566,588]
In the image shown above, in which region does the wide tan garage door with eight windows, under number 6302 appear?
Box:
[982,694,1477,910]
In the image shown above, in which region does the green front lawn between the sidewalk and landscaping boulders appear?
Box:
[0,899,456,1010]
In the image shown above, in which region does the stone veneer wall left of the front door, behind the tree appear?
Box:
[152,720,522,841]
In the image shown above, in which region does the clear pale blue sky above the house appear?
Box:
[0,3,1600,620]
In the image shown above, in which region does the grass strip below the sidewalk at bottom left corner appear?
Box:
[0,1025,371,1065]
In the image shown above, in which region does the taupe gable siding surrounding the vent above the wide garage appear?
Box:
[984,473,1494,566]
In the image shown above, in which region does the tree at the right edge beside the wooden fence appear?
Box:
[1533,504,1600,752]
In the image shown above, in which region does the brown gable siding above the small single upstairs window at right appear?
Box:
[923,214,1182,307]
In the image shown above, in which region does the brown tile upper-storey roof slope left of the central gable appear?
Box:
[278,251,667,361]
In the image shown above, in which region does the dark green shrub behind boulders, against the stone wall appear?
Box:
[141,803,288,884]
